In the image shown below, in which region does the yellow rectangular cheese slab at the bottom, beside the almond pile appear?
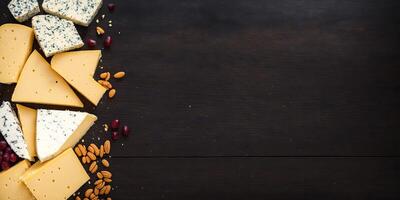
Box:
[22,148,89,200]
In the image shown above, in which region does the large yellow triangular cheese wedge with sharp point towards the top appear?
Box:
[11,51,83,107]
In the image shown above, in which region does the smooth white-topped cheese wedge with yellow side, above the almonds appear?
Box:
[36,109,97,161]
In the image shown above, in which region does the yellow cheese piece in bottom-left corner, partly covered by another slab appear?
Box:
[0,160,35,200]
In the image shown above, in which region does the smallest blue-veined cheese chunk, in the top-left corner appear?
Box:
[8,0,40,22]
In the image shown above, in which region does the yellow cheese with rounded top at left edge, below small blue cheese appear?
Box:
[0,24,33,84]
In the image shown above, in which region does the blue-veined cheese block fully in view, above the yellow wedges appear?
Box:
[32,15,83,57]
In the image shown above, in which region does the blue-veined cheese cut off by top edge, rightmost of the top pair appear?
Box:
[42,0,103,26]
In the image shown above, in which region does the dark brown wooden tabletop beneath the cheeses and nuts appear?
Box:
[0,0,400,200]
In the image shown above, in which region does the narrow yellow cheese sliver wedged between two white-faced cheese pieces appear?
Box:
[17,104,36,157]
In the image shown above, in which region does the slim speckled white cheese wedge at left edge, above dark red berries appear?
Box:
[0,101,33,160]
